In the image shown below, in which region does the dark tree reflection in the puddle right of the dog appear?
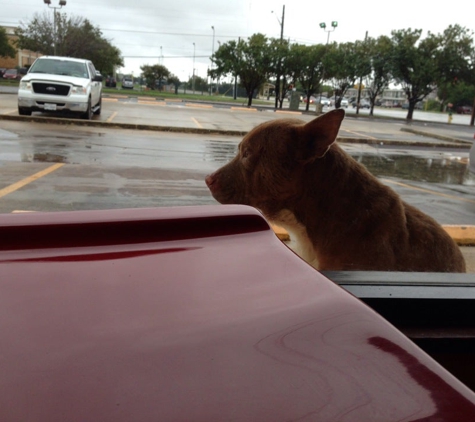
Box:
[353,155,475,185]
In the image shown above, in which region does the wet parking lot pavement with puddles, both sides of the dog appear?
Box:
[0,121,475,225]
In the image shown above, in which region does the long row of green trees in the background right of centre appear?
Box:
[209,25,475,119]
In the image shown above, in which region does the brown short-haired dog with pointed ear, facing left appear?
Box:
[206,110,465,272]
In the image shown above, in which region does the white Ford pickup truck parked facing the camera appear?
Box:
[18,56,102,120]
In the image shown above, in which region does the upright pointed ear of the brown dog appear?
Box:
[300,109,345,162]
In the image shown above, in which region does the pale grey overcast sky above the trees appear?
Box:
[0,0,475,80]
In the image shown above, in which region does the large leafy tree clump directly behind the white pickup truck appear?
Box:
[11,11,124,75]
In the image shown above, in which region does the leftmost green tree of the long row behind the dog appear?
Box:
[209,34,272,106]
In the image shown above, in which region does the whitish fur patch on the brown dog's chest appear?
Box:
[272,210,318,270]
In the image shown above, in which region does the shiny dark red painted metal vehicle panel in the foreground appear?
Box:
[0,206,475,422]
